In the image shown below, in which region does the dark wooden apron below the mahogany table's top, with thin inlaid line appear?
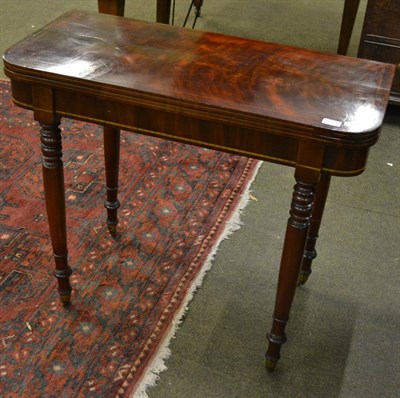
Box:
[7,80,376,176]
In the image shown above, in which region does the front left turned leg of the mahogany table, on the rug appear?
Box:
[40,119,72,305]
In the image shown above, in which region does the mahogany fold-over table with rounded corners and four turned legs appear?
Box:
[4,11,394,370]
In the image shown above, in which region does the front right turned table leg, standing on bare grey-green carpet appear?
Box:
[266,169,319,371]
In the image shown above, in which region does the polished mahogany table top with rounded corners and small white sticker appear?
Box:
[4,11,394,139]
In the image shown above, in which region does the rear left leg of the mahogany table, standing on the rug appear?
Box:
[104,127,120,236]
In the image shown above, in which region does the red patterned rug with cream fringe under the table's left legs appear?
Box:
[0,81,258,397]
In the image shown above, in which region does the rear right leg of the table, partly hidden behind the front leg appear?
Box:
[299,173,331,285]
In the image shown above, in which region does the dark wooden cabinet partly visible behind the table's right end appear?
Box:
[358,0,400,105]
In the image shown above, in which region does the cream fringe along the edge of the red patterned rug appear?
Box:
[130,161,263,398]
